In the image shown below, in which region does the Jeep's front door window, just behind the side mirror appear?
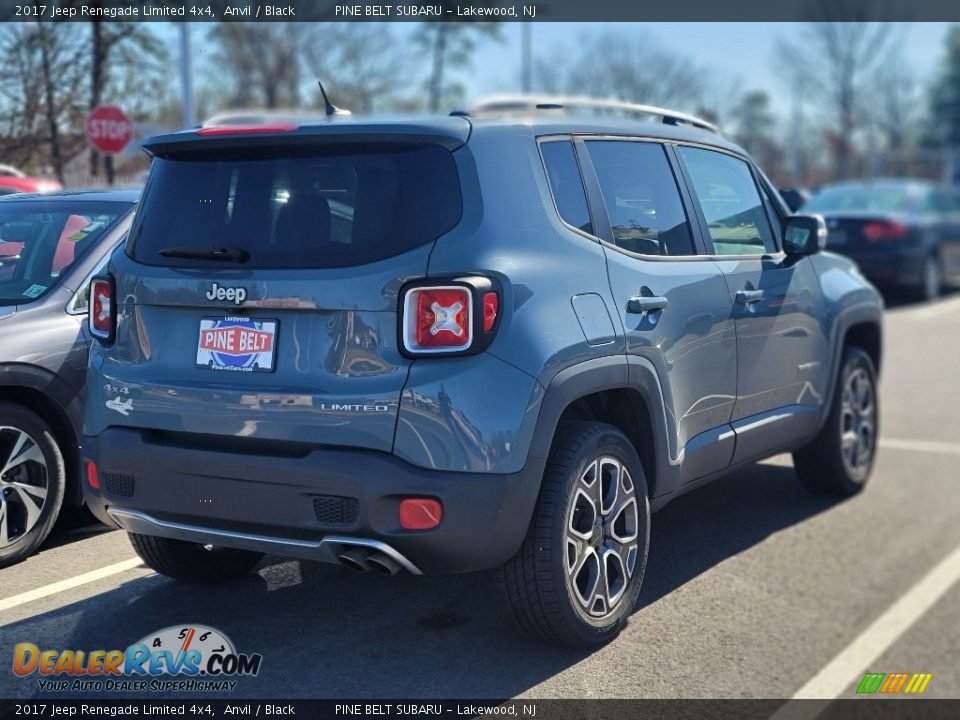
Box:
[677,146,777,255]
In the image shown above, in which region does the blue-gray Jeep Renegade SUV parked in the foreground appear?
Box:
[84,101,881,646]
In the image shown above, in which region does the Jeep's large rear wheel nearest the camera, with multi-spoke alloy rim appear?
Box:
[496,422,650,648]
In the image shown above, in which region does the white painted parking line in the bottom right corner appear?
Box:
[793,547,960,700]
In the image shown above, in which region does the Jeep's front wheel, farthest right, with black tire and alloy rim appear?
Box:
[793,347,880,497]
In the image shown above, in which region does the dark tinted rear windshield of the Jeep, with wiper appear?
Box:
[127,144,461,268]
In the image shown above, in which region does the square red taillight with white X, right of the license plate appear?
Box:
[403,285,473,353]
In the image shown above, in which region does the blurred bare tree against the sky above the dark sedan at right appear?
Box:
[778,16,896,179]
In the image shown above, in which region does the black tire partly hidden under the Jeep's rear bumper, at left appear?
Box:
[128,533,263,584]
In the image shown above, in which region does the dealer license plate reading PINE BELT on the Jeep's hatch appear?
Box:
[197,317,278,372]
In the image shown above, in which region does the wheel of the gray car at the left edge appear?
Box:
[0,402,67,567]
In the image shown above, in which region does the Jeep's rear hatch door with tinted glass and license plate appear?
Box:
[101,124,461,451]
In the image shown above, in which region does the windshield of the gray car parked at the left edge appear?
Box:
[0,200,129,305]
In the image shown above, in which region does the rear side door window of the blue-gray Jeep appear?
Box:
[586,140,695,255]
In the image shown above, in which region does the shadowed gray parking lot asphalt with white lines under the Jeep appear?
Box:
[0,294,960,698]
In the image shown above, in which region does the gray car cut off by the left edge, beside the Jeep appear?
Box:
[0,191,139,566]
